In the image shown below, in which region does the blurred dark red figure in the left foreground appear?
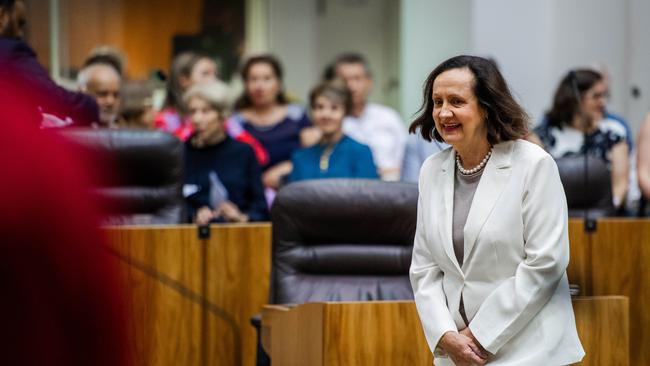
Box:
[0,89,131,365]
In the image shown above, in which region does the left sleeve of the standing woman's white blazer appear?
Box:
[409,186,458,353]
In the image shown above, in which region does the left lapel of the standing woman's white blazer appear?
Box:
[438,149,463,273]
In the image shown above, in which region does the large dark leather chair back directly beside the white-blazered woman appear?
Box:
[270,179,418,303]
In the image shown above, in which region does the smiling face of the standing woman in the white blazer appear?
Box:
[432,68,487,150]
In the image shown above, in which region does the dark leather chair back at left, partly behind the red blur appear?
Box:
[60,128,184,225]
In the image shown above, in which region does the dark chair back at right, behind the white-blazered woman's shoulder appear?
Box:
[555,155,616,219]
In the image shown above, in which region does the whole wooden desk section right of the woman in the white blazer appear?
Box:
[567,219,650,365]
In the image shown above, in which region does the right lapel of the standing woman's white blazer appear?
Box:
[463,141,514,266]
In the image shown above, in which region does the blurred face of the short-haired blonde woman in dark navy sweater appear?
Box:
[187,97,225,146]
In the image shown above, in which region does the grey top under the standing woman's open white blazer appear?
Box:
[452,168,484,267]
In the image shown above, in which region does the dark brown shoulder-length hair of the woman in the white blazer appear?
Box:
[409,55,529,145]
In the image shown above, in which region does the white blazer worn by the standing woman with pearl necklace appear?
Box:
[410,140,584,366]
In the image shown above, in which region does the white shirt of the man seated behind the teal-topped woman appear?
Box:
[343,103,406,180]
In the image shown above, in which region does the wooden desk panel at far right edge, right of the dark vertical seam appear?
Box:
[592,220,650,365]
